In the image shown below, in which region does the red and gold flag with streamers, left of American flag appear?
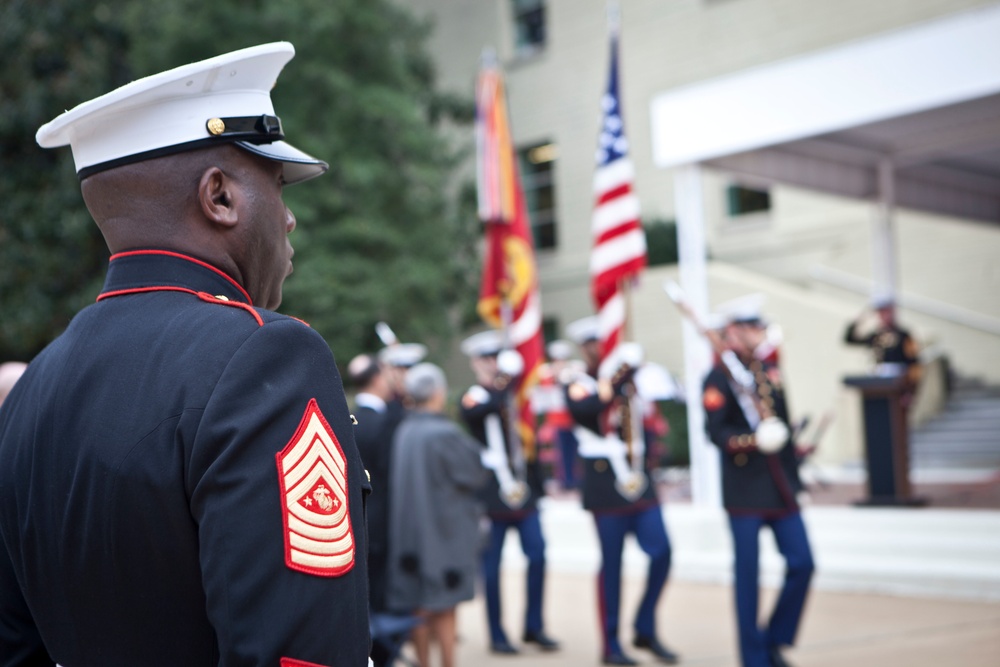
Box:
[476,57,543,460]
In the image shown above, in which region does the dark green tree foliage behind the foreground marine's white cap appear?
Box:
[0,0,478,362]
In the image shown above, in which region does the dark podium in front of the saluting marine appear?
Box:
[844,373,927,507]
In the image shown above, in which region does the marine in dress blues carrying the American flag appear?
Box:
[566,317,679,665]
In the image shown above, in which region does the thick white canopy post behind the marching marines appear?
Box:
[674,164,722,507]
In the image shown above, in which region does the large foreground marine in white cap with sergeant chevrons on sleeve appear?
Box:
[0,43,369,667]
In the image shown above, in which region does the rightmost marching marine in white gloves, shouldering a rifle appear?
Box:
[702,298,814,667]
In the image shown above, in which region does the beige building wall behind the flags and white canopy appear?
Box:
[397,0,1000,463]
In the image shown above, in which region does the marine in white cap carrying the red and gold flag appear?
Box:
[460,331,559,654]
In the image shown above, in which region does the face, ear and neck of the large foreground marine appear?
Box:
[81,144,295,310]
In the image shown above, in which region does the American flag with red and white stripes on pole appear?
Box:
[590,28,646,359]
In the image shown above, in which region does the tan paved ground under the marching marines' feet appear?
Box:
[458,572,1000,667]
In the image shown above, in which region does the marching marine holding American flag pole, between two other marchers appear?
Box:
[566,317,679,665]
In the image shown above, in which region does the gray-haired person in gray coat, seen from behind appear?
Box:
[387,363,487,667]
